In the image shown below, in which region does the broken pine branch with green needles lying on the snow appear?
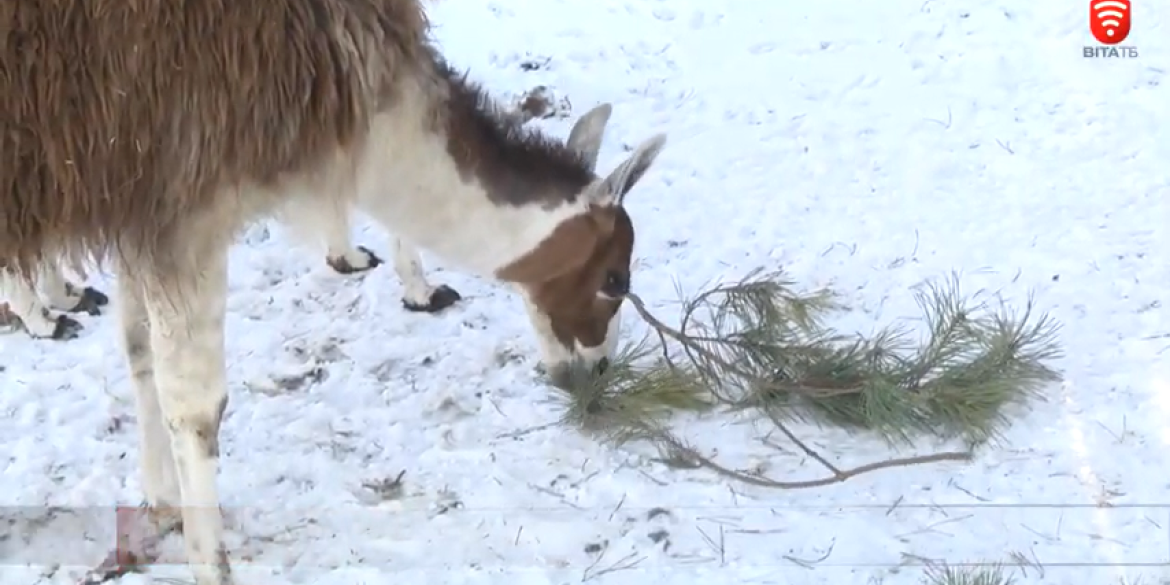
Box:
[552,270,1062,489]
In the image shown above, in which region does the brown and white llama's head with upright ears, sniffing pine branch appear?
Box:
[489,104,666,387]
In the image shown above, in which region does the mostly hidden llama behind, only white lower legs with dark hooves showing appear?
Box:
[0,229,462,340]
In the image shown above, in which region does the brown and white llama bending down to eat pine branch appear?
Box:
[0,0,666,585]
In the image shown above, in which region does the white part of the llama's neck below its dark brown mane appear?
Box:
[346,95,585,276]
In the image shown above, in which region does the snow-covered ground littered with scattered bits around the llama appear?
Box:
[0,0,1170,585]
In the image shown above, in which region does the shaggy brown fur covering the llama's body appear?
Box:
[0,0,431,275]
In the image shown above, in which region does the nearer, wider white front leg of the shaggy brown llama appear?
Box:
[143,246,232,585]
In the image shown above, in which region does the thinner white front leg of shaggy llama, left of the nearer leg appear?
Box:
[118,278,183,530]
